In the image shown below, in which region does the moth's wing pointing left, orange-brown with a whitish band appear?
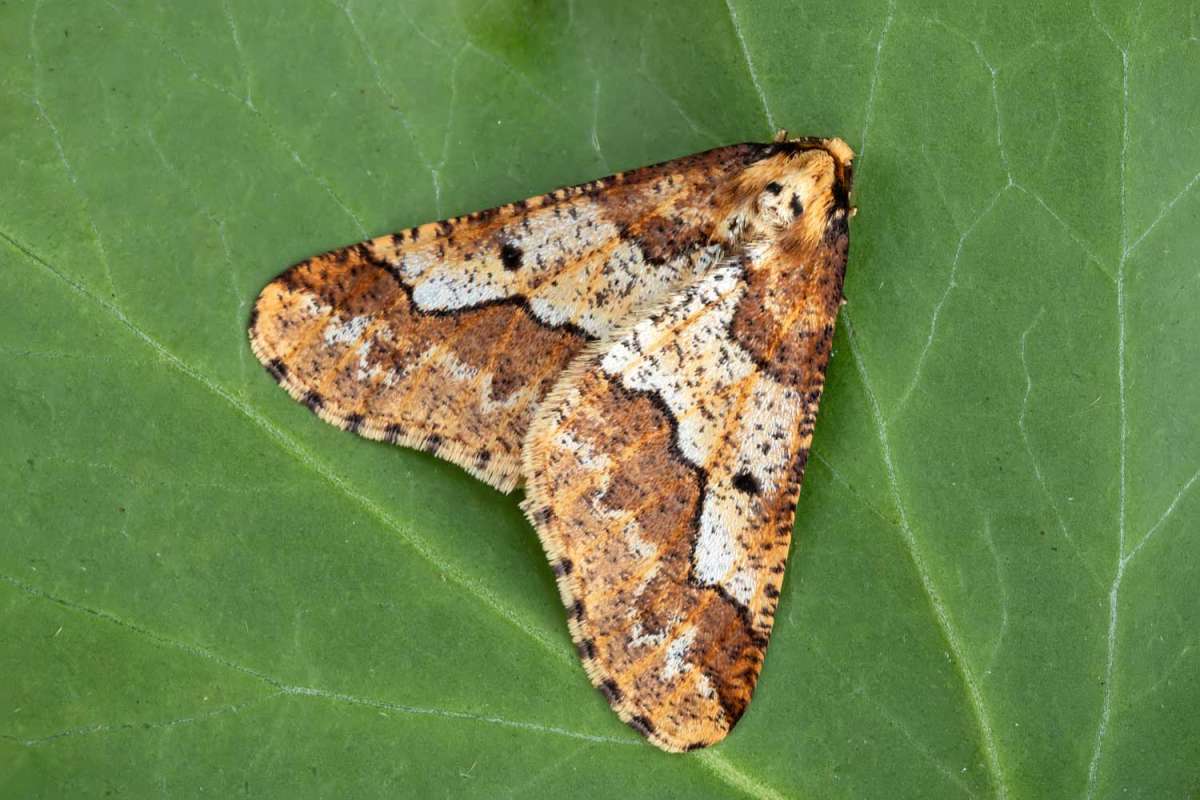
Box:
[250,144,778,492]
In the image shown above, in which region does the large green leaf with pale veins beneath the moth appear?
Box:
[0,0,1200,799]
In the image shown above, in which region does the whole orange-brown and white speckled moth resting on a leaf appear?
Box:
[250,132,854,751]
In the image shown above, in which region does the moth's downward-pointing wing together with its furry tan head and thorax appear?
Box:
[523,140,853,751]
